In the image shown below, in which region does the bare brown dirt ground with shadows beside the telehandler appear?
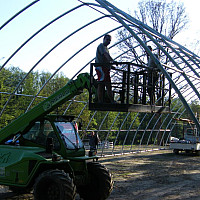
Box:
[0,150,200,200]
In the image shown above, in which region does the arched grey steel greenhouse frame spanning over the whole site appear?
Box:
[0,0,200,156]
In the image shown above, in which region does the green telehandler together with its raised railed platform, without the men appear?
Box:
[0,63,171,200]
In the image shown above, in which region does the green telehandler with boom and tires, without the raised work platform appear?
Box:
[0,73,113,200]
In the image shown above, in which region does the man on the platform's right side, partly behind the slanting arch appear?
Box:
[147,46,159,105]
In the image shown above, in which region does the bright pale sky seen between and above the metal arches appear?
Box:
[0,0,200,78]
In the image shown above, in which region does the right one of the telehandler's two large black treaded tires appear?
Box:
[77,162,113,200]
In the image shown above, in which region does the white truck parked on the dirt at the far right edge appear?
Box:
[170,119,200,155]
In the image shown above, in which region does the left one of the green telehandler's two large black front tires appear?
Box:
[33,170,76,200]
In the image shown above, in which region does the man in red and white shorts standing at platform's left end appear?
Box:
[95,34,114,103]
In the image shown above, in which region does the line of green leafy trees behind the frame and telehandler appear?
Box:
[0,67,200,144]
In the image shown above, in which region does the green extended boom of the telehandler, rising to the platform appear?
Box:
[0,73,90,144]
